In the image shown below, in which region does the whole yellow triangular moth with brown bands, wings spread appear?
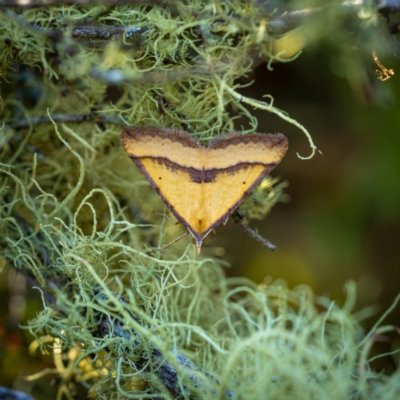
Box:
[121,127,288,251]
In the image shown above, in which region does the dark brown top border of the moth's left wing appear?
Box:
[121,126,201,149]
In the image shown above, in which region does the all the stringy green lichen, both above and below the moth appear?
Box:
[0,1,400,399]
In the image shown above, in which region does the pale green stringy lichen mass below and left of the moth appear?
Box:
[0,124,400,399]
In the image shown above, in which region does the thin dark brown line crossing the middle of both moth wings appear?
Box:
[129,155,278,184]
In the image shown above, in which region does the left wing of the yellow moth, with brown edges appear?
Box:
[121,127,206,247]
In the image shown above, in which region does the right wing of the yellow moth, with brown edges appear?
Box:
[201,133,288,245]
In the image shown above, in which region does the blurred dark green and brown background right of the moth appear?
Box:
[0,7,400,398]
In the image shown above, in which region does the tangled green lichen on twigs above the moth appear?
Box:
[0,1,300,140]
